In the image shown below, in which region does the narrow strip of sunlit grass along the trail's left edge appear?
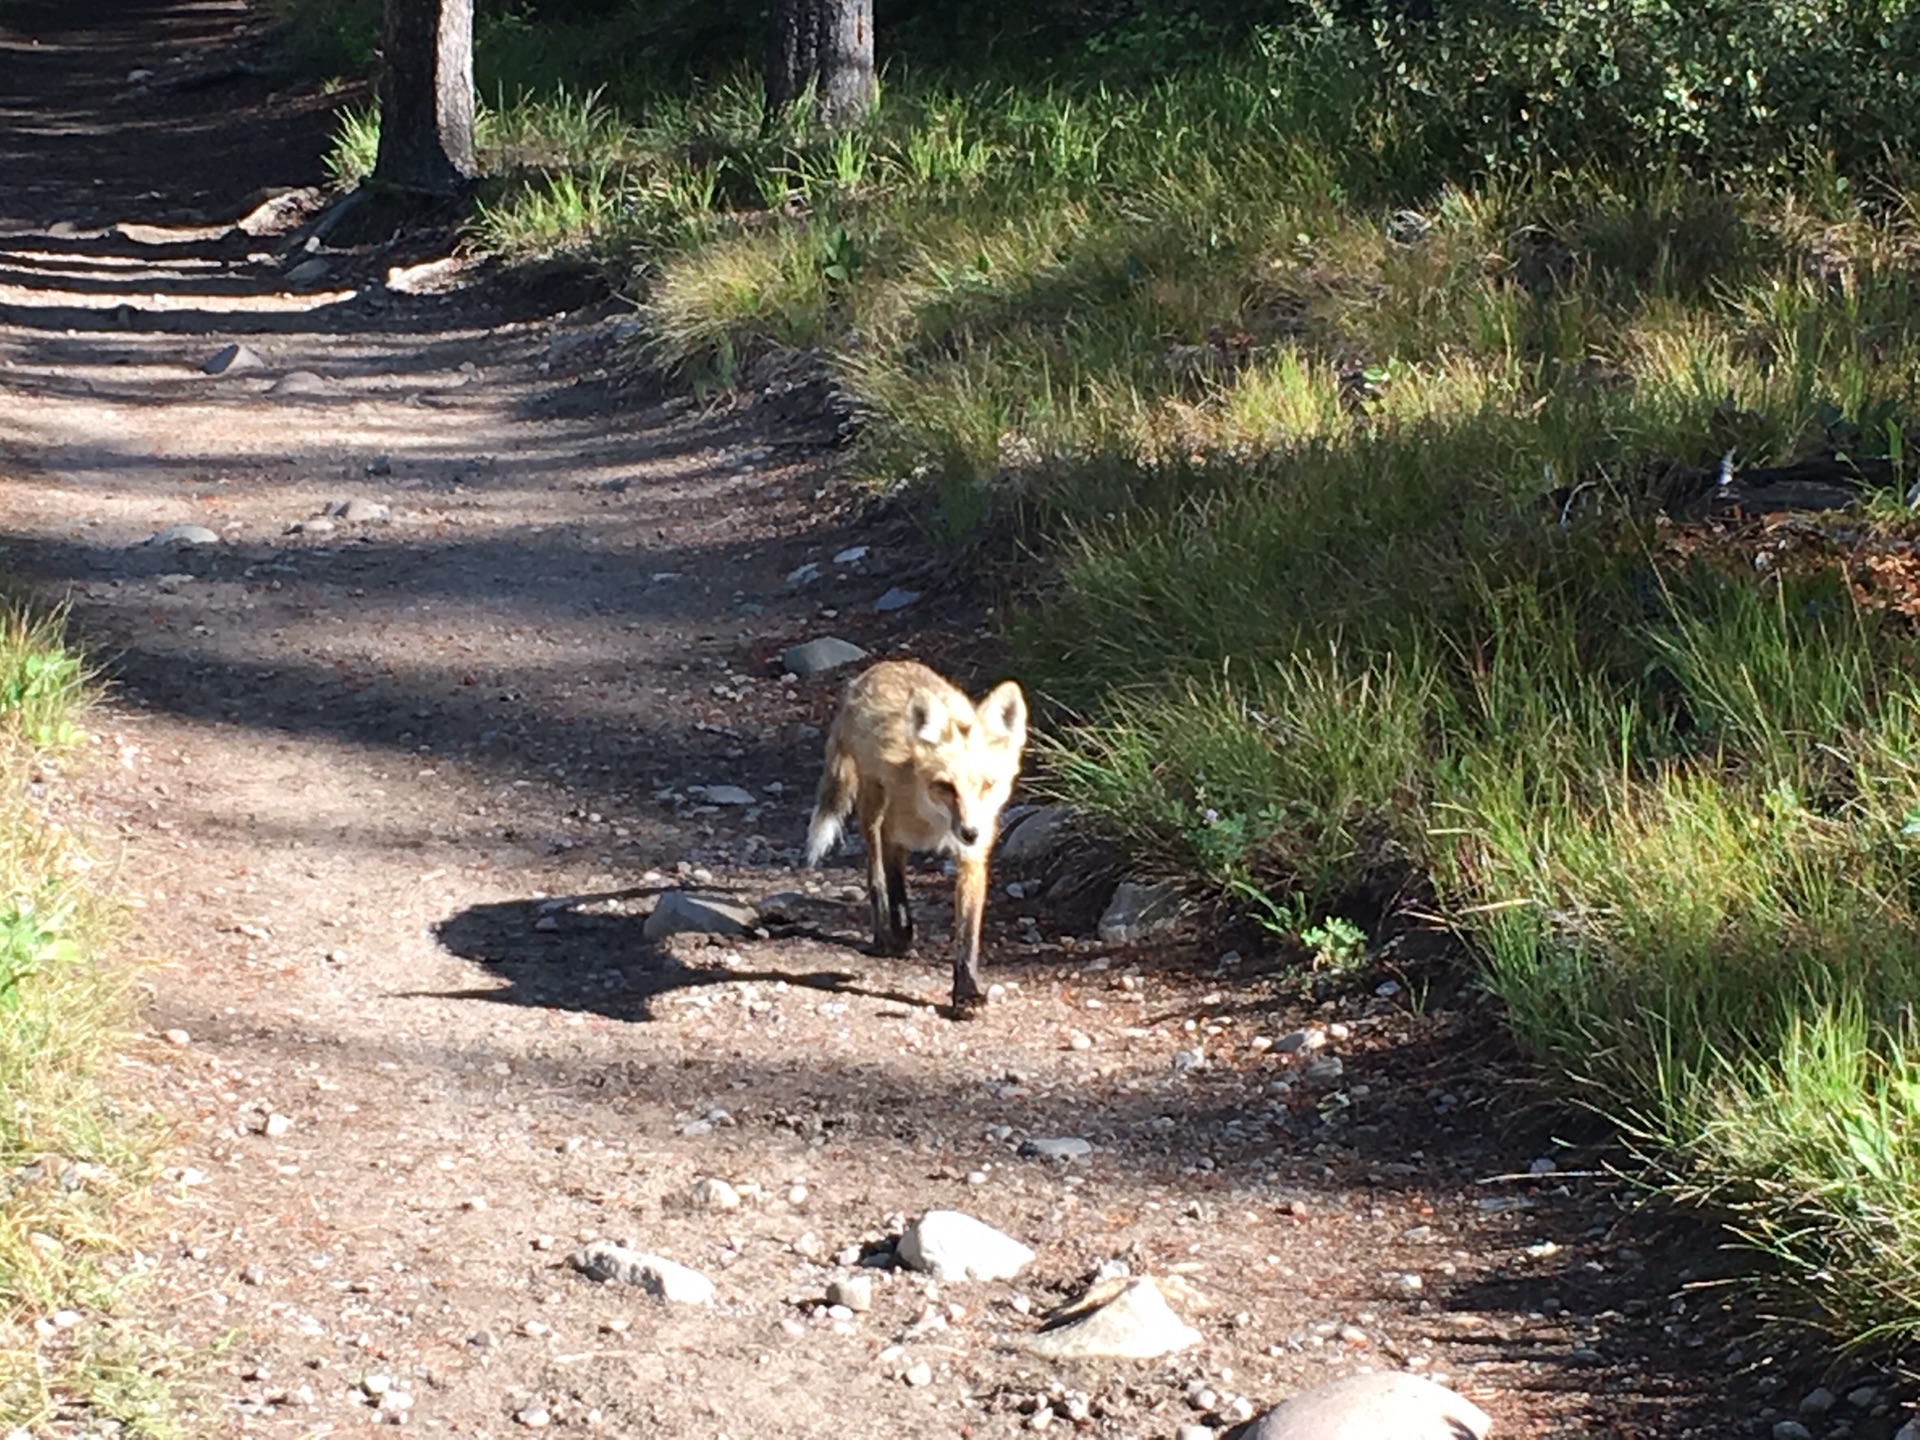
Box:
[0,601,175,1436]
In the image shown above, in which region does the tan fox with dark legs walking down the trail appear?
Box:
[806,660,1027,1014]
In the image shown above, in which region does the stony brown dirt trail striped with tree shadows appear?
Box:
[0,0,1781,1440]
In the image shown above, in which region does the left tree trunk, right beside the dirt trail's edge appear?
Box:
[372,0,478,196]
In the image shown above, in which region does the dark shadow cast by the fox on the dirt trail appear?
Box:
[424,887,925,1021]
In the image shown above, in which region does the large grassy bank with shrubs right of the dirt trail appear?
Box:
[311,0,1920,1348]
